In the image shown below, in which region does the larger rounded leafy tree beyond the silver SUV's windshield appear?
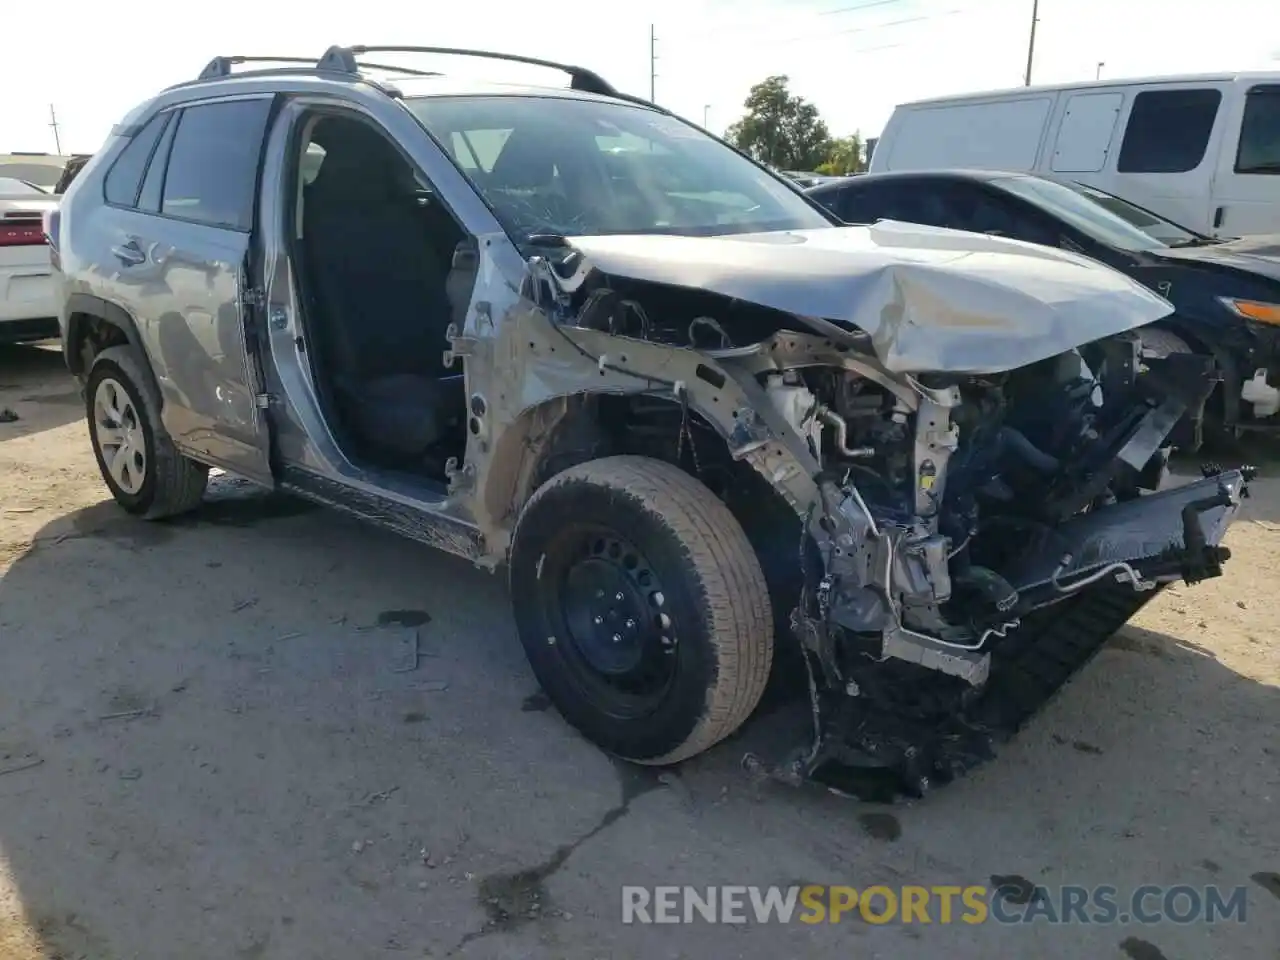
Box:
[726,76,831,170]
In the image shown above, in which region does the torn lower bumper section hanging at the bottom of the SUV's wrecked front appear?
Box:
[746,467,1254,799]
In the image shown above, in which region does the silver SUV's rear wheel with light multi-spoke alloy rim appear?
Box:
[84,347,209,520]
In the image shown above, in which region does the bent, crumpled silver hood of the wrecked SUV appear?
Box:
[566,220,1172,374]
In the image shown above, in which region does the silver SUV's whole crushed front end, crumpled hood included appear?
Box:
[521,224,1251,794]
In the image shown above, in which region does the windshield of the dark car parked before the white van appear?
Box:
[993,177,1204,252]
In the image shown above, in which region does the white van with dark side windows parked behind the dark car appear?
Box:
[870,72,1280,237]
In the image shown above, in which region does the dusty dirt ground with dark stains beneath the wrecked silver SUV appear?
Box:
[0,347,1280,960]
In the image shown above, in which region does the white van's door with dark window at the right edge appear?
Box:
[1212,83,1280,237]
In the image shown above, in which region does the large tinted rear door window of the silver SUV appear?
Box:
[160,99,271,230]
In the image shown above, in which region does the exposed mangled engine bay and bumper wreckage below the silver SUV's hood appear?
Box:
[753,334,1249,794]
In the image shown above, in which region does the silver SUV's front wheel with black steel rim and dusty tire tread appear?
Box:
[509,457,773,764]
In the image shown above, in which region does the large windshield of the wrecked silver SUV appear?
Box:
[406,96,831,243]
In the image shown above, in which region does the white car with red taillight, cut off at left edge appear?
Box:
[0,177,58,343]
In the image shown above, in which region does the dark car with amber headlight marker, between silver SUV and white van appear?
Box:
[809,170,1280,434]
